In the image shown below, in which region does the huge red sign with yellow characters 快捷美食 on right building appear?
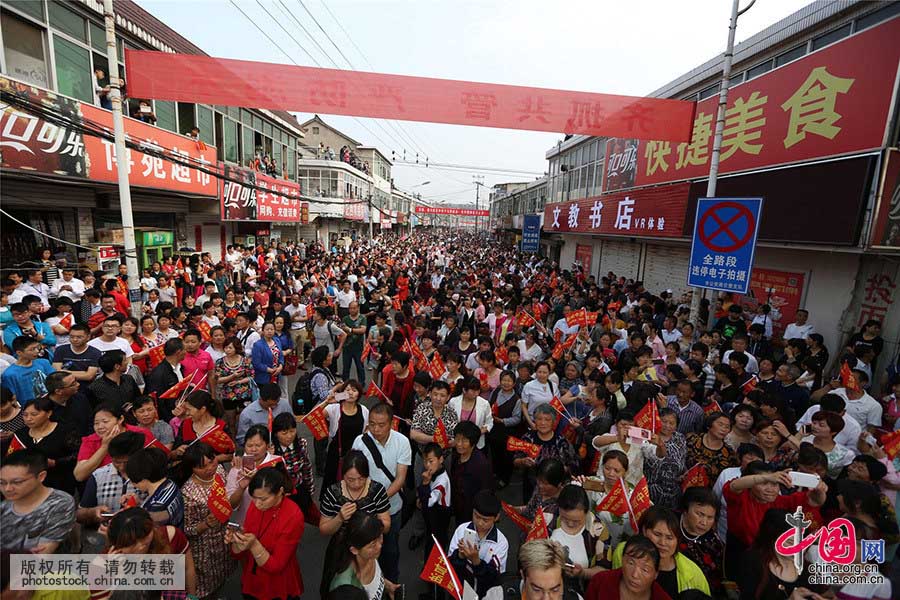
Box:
[605,19,900,191]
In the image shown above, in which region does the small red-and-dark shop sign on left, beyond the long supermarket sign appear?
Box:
[219,164,309,223]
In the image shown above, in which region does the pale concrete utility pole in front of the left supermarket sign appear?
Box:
[103,0,141,318]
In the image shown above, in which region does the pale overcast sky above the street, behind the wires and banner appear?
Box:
[137,0,809,206]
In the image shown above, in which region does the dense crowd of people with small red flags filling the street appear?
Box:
[0,232,900,600]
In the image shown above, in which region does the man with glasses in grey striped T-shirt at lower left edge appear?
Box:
[0,448,75,554]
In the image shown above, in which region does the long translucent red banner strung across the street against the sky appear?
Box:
[125,50,694,142]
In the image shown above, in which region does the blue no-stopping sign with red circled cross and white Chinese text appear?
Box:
[688,198,762,294]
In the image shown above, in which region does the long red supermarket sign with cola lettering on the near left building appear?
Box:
[0,77,217,196]
